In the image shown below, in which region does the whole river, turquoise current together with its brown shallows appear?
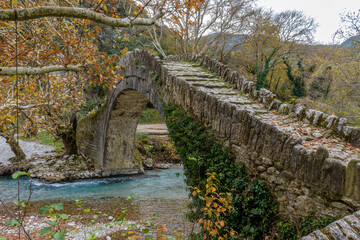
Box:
[0,167,192,238]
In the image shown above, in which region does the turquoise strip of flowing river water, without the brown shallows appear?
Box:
[0,168,188,202]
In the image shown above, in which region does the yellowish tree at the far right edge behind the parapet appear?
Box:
[304,10,360,125]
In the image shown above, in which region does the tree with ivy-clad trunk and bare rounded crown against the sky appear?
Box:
[243,9,316,89]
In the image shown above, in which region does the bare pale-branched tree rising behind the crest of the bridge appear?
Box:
[153,0,254,57]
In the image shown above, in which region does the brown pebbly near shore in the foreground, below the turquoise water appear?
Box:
[0,198,194,240]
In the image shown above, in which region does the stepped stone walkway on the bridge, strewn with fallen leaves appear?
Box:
[164,62,360,164]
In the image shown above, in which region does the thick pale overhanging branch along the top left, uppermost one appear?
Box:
[0,6,163,27]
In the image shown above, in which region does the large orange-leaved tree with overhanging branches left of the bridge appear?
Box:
[0,0,190,157]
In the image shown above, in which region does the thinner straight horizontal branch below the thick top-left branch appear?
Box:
[0,65,84,76]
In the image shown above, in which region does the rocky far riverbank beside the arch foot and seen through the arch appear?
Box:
[0,124,180,182]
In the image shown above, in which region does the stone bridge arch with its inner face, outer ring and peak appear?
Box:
[97,54,165,175]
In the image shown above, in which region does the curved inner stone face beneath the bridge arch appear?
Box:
[102,82,165,175]
